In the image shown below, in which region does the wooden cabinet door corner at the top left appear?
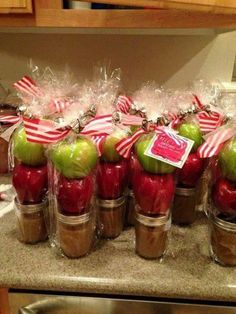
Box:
[0,0,32,14]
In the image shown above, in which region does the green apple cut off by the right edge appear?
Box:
[219,139,236,181]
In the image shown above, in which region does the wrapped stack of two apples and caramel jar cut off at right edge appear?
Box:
[207,141,236,266]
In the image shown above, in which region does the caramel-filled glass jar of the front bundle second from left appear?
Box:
[57,212,96,258]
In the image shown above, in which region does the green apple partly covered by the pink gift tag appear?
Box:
[135,135,175,174]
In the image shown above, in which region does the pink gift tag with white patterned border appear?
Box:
[144,128,194,168]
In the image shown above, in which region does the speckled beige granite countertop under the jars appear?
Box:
[0,199,236,302]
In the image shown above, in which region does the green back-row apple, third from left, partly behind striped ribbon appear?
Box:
[101,130,127,162]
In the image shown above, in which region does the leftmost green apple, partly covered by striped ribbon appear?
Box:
[13,128,47,166]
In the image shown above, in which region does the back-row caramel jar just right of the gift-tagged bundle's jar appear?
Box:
[172,187,197,225]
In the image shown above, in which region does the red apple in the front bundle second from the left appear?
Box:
[57,175,94,216]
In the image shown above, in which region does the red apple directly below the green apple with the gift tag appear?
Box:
[133,171,175,215]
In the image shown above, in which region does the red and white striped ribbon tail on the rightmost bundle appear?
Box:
[198,125,236,158]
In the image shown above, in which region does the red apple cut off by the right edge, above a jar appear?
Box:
[212,178,236,215]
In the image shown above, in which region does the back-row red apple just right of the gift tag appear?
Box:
[178,153,204,187]
